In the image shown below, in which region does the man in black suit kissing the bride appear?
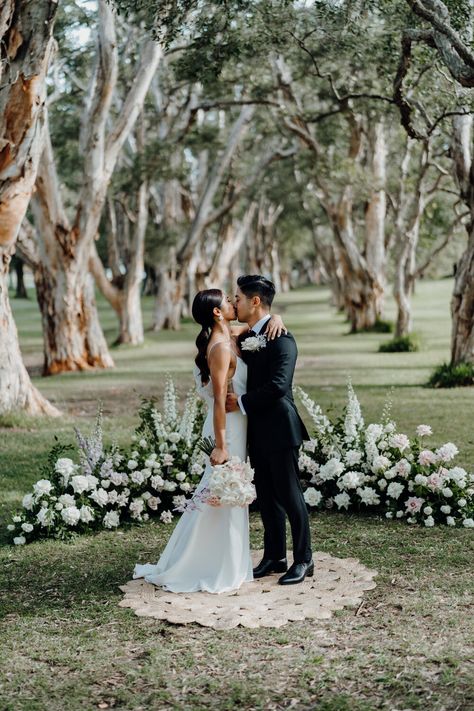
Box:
[226,275,314,585]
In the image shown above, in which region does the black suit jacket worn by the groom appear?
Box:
[242,326,309,451]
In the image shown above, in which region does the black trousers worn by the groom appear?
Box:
[249,446,311,563]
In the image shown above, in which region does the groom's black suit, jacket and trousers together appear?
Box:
[242,324,311,563]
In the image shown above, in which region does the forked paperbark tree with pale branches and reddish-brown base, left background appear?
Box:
[33,0,162,375]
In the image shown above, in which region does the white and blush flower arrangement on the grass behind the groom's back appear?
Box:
[297,383,474,528]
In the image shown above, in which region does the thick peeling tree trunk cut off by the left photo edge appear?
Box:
[0,0,60,415]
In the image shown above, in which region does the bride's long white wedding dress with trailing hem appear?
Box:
[133,357,253,593]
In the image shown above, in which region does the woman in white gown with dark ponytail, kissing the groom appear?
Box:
[133,289,285,593]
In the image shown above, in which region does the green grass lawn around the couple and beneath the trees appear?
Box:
[0,280,474,711]
